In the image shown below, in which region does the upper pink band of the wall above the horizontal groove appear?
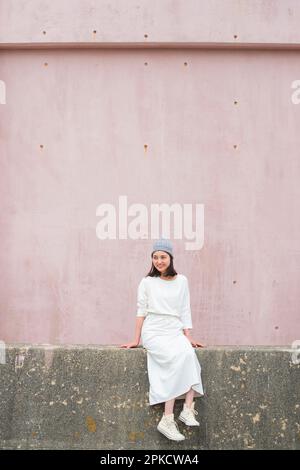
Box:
[0,0,300,46]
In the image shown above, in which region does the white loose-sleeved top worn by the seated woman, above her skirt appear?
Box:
[136,274,193,328]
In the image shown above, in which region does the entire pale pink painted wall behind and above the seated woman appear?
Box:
[0,0,300,345]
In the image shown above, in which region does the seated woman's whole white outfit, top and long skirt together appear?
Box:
[137,274,204,405]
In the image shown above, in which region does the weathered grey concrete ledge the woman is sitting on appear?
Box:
[0,344,300,450]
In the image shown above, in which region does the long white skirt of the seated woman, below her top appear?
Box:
[141,313,204,405]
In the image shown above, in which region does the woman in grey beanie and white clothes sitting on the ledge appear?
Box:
[121,238,204,441]
